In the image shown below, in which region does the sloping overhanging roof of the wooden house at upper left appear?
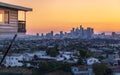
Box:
[0,2,32,11]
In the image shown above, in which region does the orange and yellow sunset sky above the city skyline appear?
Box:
[0,0,120,34]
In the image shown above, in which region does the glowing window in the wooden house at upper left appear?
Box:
[0,10,9,24]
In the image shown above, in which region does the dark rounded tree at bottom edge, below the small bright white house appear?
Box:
[92,63,112,75]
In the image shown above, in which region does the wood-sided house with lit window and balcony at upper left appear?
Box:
[0,2,32,34]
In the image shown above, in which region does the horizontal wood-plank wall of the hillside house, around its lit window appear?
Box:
[0,7,18,34]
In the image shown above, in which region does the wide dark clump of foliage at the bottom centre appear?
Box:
[34,62,71,74]
